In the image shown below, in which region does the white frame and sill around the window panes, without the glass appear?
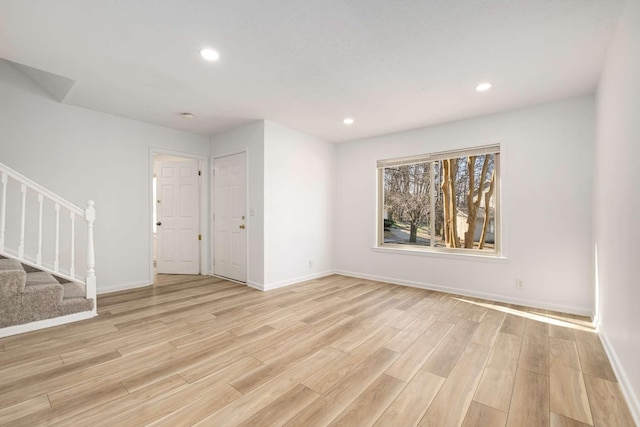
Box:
[374,144,503,258]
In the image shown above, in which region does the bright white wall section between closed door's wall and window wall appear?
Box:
[264,121,335,289]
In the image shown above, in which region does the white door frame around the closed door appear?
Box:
[208,147,252,285]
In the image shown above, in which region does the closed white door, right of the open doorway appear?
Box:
[213,153,247,282]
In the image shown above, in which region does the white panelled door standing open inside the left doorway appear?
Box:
[156,160,200,274]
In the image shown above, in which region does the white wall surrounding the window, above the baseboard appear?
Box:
[334,96,595,314]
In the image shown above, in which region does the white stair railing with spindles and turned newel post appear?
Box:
[0,163,97,313]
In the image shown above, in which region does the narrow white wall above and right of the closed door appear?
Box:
[211,121,264,288]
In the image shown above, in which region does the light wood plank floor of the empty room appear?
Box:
[0,276,634,427]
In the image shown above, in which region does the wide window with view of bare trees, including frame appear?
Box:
[378,145,500,255]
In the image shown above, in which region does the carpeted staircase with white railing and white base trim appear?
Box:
[0,163,97,337]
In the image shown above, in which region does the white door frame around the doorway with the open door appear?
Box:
[148,147,211,284]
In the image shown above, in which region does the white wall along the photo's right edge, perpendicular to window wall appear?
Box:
[594,0,640,425]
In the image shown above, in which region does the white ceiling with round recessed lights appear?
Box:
[0,0,624,142]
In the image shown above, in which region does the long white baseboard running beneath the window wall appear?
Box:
[335,270,593,317]
